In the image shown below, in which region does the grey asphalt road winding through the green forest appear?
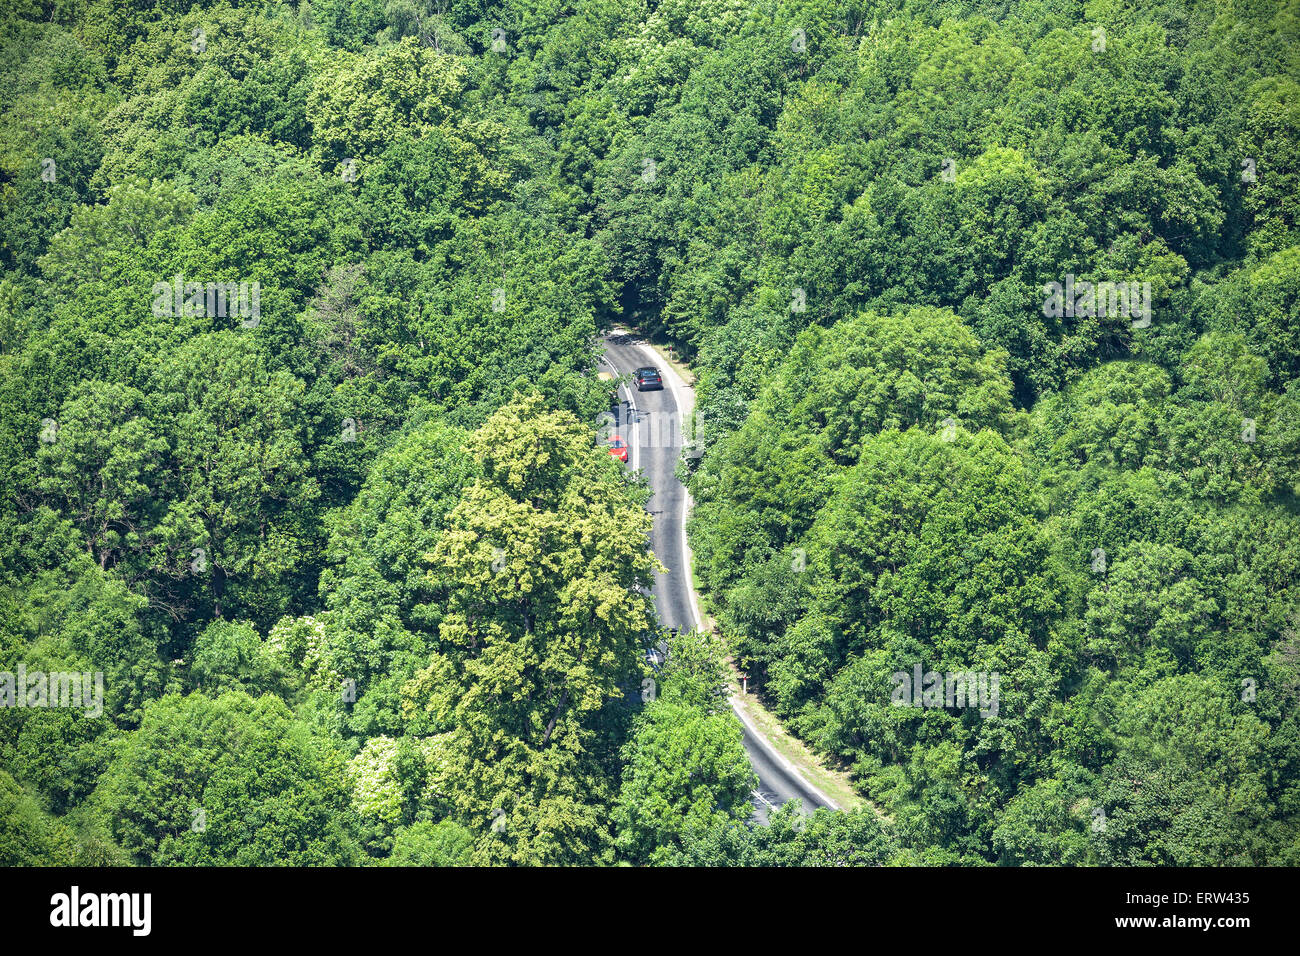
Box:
[601,332,837,821]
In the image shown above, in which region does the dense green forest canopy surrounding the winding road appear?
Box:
[0,0,1300,865]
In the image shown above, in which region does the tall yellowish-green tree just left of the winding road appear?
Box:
[406,394,655,864]
